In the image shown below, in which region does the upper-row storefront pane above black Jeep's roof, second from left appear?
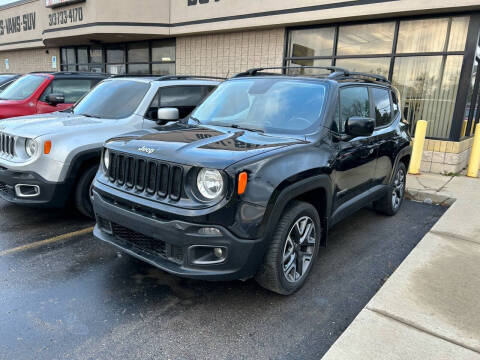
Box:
[337,22,395,55]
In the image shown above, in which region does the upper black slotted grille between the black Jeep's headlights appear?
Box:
[108,152,184,201]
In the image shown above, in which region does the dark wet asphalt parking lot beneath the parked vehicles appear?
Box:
[0,200,445,360]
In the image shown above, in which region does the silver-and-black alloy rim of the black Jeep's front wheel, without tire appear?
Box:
[282,216,316,282]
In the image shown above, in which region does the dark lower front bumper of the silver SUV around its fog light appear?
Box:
[0,166,69,207]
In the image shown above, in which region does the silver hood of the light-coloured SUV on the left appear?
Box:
[0,112,112,138]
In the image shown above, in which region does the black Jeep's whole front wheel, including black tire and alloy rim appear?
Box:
[255,201,322,295]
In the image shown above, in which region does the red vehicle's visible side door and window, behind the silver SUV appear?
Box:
[37,78,98,114]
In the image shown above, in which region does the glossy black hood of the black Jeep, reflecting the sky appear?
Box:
[108,125,305,169]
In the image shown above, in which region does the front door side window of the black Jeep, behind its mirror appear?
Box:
[338,86,370,133]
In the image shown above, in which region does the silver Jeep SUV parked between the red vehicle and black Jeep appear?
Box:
[0,76,219,216]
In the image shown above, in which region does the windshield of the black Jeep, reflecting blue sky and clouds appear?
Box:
[192,78,326,134]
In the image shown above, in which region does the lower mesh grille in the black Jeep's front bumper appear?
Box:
[111,223,184,264]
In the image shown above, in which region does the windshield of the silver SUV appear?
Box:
[73,80,150,119]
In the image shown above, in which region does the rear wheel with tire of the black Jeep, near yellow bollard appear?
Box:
[373,162,407,216]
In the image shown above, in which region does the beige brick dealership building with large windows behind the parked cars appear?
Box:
[0,0,480,173]
